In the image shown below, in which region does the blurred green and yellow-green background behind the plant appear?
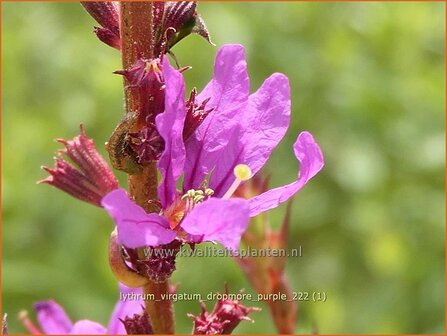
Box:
[2,2,445,333]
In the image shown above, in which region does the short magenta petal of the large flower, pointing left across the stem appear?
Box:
[101,189,176,248]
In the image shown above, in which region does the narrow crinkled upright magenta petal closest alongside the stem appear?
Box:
[155,57,186,208]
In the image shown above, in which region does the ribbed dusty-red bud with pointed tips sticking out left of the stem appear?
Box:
[39,125,118,206]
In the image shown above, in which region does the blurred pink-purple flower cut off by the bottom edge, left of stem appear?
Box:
[21,284,143,335]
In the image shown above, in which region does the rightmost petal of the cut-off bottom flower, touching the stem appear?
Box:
[108,284,144,335]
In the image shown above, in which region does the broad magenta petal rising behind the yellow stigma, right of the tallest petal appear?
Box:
[210,73,290,197]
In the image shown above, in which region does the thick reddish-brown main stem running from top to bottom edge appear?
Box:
[120,1,174,334]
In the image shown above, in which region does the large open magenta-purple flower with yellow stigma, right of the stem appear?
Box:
[102,45,324,253]
